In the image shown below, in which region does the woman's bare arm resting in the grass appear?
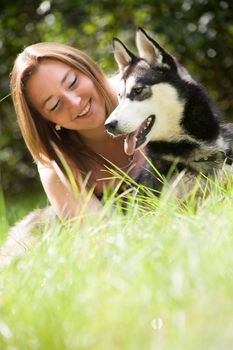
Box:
[38,163,102,219]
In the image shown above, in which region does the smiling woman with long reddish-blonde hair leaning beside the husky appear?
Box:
[11,43,146,218]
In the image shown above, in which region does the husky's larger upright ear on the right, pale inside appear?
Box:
[136,28,177,69]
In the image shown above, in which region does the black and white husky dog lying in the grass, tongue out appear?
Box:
[105,28,233,189]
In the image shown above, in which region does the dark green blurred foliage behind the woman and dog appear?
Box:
[0,0,233,192]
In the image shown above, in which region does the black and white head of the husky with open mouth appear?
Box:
[105,28,193,154]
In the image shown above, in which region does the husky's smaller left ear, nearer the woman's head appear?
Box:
[112,38,136,71]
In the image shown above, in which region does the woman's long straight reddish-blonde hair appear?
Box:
[10,42,117,173]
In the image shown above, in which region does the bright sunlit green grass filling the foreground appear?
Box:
[0,178,233,350]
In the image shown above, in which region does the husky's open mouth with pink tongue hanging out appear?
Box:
[124,114,155,155]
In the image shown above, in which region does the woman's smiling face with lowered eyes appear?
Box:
[26,59,105,131]
